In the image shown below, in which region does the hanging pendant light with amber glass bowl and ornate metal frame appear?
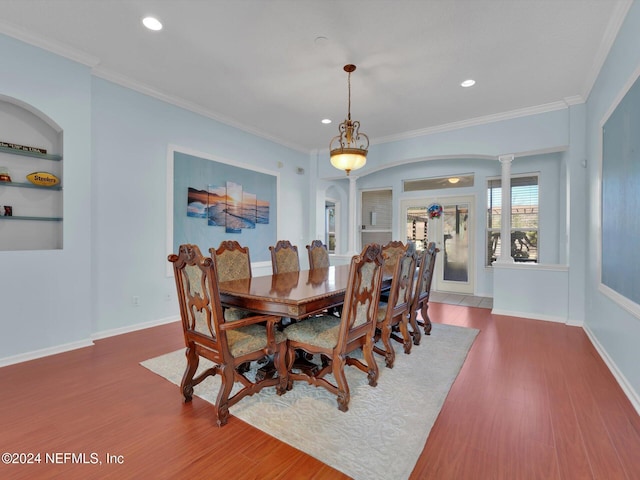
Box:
[329,64,369,175]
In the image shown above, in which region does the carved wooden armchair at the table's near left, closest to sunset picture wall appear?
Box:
[168,244,288,427]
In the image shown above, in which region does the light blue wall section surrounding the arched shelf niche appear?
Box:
[0,35,92,360]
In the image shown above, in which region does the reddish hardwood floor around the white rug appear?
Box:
[0,303,640,480]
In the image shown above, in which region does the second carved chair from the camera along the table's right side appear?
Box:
[373,243,418,368]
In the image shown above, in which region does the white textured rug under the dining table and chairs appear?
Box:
[142,323,478,480]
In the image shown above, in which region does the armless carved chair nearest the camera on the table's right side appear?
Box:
[284,244,384,412]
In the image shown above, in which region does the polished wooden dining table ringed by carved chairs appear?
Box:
[219,265,352,320]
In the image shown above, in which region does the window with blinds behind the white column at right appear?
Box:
[487,174,539,265]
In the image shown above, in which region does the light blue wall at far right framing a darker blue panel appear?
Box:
[586,2,640,408]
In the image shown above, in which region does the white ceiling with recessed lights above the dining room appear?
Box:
[0,0,630,152]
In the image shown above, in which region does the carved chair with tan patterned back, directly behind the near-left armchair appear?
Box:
[209,240,253,321]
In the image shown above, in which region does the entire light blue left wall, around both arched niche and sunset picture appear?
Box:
[0,35,310,365]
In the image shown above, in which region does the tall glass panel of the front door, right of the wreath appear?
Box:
[440,204,469,282]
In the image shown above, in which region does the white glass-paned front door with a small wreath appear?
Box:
[401,196,475,295]
